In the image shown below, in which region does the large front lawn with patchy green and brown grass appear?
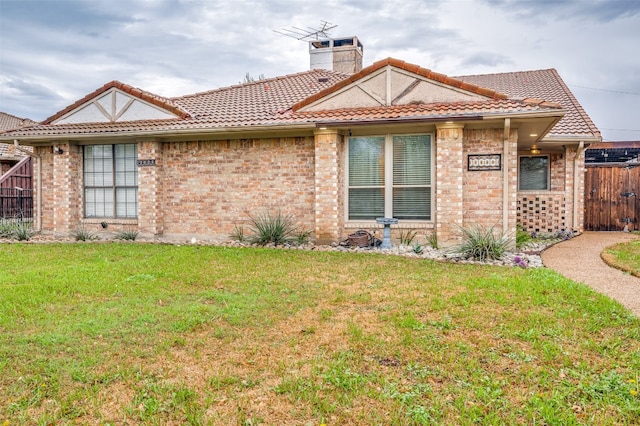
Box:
[0,243,640,426]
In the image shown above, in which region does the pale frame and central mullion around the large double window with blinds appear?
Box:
[344,133,436,223]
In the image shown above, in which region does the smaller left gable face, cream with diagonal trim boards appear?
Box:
[52,87,177,124]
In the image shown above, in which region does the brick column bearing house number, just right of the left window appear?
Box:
[138,141,164,237]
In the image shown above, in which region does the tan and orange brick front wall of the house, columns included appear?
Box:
[34,124,584,246]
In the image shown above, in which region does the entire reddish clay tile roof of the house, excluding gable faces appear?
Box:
[0,58,599,139]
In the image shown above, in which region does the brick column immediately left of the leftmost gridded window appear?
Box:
[51,142,84,235]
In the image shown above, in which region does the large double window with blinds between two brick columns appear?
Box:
[348,135,432,220]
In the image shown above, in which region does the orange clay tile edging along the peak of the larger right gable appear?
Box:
[291,58,508,111]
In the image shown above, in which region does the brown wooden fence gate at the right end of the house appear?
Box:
[584,164,640,231]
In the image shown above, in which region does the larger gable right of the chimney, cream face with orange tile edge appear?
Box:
[293,58,506,111]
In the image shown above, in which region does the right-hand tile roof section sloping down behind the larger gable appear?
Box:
[456,68,601,139]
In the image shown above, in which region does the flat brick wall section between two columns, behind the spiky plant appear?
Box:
[160,137,316,239]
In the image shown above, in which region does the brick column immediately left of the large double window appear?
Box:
[314,130,342,244]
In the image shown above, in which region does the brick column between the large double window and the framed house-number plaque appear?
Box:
[435,123,464,247]
